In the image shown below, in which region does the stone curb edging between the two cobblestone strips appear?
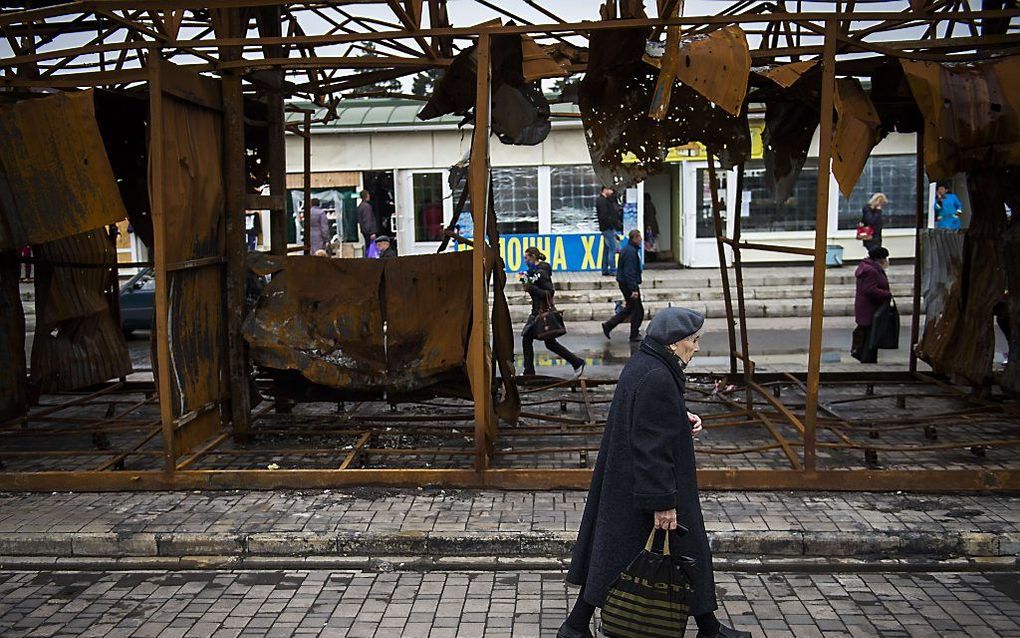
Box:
[0,531,1020,561]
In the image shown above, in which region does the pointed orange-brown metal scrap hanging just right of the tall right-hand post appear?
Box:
[832,78,882,197]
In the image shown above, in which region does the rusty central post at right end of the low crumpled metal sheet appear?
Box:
[467,32,496,471]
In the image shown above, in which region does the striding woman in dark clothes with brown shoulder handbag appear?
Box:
[520,246,584,377]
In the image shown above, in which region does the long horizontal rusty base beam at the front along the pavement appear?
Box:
[0,468,1020,493]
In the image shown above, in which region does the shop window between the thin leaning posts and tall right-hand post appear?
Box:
[738,160,818,233]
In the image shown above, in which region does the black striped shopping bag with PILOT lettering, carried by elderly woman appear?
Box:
[602,530,694,638]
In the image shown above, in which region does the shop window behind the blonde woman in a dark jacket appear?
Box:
[839,155,917,230]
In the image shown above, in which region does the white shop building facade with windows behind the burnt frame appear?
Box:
[288,99,934,269]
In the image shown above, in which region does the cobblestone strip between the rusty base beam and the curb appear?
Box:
[0,489,1020,537]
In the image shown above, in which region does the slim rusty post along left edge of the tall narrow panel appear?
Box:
[148,55,176,474]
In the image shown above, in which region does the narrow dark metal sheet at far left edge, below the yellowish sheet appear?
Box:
[0,251,29,421]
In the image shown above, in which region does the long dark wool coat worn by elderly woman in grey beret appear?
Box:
[567,345,718,615]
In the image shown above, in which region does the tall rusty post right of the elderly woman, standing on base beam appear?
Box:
[804,18,839,472]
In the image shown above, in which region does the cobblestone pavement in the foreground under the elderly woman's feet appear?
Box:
[0,572,1020,638]
